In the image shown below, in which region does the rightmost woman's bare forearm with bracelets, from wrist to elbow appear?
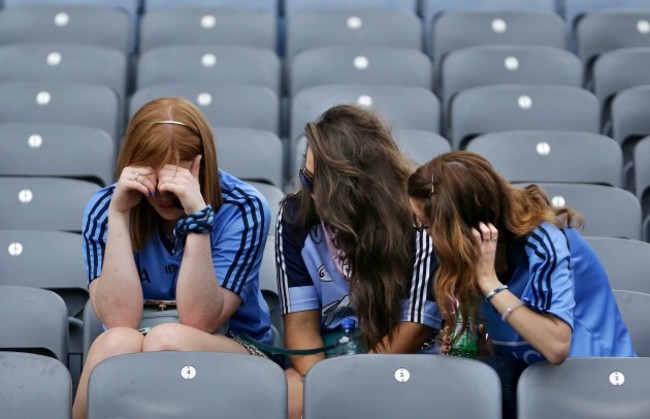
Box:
[490,290,571,364]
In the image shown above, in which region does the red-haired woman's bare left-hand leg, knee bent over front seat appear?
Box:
[72,327,144,419]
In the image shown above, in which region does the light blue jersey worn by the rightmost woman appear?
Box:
[481,223,636,364]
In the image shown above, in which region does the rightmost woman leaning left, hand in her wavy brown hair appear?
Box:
[408,151,635,417]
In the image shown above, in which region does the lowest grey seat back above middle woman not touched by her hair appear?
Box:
[288,45,433,96]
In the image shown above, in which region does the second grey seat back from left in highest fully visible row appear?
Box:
[139,7,277,54]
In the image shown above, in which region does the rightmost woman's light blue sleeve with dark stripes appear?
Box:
[521,223,575,328]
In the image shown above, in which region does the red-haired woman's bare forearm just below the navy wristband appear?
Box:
[176,234,227,333]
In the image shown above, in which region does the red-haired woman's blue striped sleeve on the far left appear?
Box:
[81,185,115,283]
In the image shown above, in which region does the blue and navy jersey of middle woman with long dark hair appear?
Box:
[275,202,441,349]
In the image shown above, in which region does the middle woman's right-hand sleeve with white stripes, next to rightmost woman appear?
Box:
[402,230,442,329]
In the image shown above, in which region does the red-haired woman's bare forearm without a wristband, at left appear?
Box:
[91,213,143,328]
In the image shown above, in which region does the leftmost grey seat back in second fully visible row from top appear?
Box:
[0,42,127,104]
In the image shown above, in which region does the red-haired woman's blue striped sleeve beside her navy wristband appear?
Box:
[212,187,270,298]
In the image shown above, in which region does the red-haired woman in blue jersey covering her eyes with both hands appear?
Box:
[73,97,271,418]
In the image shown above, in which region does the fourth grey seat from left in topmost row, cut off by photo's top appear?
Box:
[420,0,557,57]
